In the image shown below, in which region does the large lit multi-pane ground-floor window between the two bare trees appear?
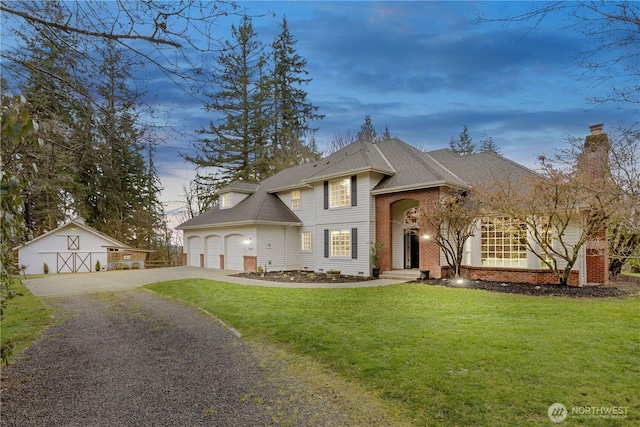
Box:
[481,217,527,267]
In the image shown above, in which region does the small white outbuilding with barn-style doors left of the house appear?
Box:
[14,218,151,274]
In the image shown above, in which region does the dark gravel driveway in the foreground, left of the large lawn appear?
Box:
[0,290,382,427]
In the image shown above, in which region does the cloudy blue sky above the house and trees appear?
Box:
[152,1,637,226]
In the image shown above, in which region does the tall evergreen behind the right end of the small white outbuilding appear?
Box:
[82,42,162,247]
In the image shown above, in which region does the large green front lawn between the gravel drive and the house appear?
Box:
[148,279,640,426]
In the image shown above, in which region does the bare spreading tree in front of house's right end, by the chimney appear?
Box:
[484,157,616,285]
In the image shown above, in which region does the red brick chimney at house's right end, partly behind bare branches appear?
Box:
[578,123,611,283]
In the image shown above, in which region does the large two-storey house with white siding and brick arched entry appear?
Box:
[178,128,608,285]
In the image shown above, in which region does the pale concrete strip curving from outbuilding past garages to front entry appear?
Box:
[24,267,403,297]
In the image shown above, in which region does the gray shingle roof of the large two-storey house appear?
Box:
[178,138,535,229]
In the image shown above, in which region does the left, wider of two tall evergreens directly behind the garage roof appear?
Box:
[184,16,270,196]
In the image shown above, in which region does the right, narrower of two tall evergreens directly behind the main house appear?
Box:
[271,18,324,170]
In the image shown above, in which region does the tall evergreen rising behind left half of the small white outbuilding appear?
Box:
[5,3,87,235]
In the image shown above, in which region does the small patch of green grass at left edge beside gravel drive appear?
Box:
[0,280,51,364]
